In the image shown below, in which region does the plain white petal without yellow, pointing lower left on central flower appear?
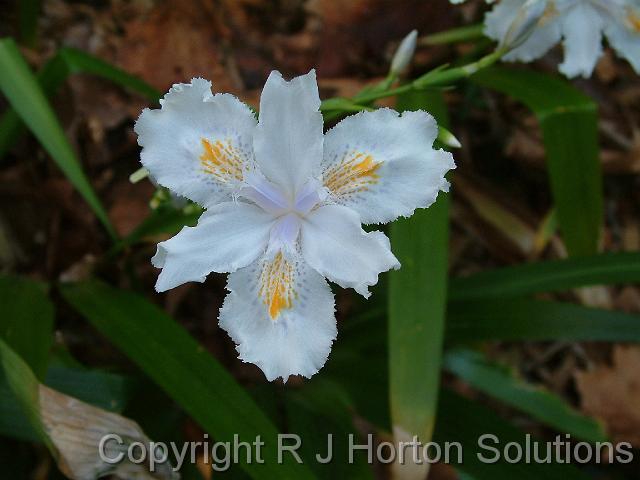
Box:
[152,202,275,292]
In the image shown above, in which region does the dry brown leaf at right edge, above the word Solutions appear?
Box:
[576,345,640,447]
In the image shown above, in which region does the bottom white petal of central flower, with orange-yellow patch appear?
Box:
[220,254,337,381]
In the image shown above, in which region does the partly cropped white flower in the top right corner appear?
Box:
[451,0,640,77]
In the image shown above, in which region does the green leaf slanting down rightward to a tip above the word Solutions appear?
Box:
[444,349,607,442]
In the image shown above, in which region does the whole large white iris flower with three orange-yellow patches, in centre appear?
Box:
[135,70,455,381]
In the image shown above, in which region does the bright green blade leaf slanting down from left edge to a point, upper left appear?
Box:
[0,38,116,238]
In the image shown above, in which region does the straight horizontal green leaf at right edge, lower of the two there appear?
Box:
[447,298,640,343]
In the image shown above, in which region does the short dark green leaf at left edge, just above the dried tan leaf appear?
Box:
[0,276,53,379]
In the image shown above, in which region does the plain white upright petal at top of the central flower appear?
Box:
[253,70,323,199]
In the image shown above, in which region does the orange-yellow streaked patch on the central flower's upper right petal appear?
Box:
[324,152,381,195]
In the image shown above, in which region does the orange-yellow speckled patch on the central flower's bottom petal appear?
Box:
[259,252,295,320]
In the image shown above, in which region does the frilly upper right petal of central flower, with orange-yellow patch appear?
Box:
[322,108,455,223]
